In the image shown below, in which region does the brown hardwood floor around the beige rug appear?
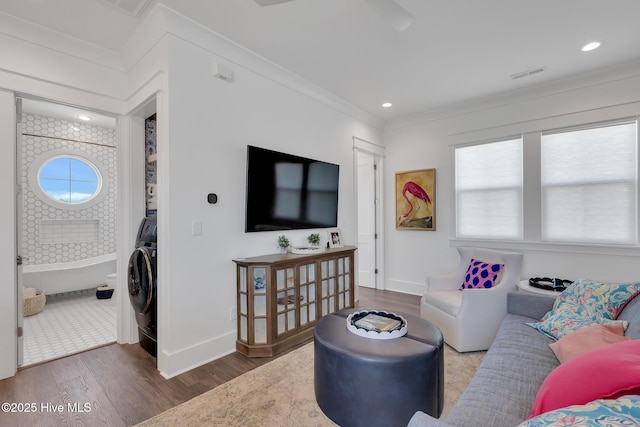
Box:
[0,287,420,427]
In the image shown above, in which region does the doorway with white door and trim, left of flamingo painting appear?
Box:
[354,138,383,289]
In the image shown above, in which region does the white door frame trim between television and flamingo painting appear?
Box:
[352,136,385,289]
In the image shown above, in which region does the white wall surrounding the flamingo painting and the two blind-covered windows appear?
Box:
[384,63,640,294]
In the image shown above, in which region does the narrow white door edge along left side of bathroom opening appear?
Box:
[16,98,24,366]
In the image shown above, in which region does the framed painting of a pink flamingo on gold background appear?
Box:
[396,169,436,231]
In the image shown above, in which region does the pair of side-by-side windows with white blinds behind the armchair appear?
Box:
[452,117,640,254]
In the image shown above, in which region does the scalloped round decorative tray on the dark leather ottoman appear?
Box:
[347,310,407,340]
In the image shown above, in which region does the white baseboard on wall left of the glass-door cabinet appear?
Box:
[158,330,237,379]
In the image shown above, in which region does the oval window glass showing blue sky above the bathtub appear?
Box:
[38,155,102,204]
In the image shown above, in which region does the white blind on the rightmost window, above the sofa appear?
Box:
[541,121,638,244]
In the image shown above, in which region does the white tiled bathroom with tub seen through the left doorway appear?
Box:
[16,99,117,366]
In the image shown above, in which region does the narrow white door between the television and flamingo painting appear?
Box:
[356,150,376,288]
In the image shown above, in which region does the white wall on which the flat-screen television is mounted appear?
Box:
[158,31,381,376]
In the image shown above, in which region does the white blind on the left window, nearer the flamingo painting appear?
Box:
[455,138,523,239]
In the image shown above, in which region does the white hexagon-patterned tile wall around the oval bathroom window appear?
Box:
[21,113,117,265]
